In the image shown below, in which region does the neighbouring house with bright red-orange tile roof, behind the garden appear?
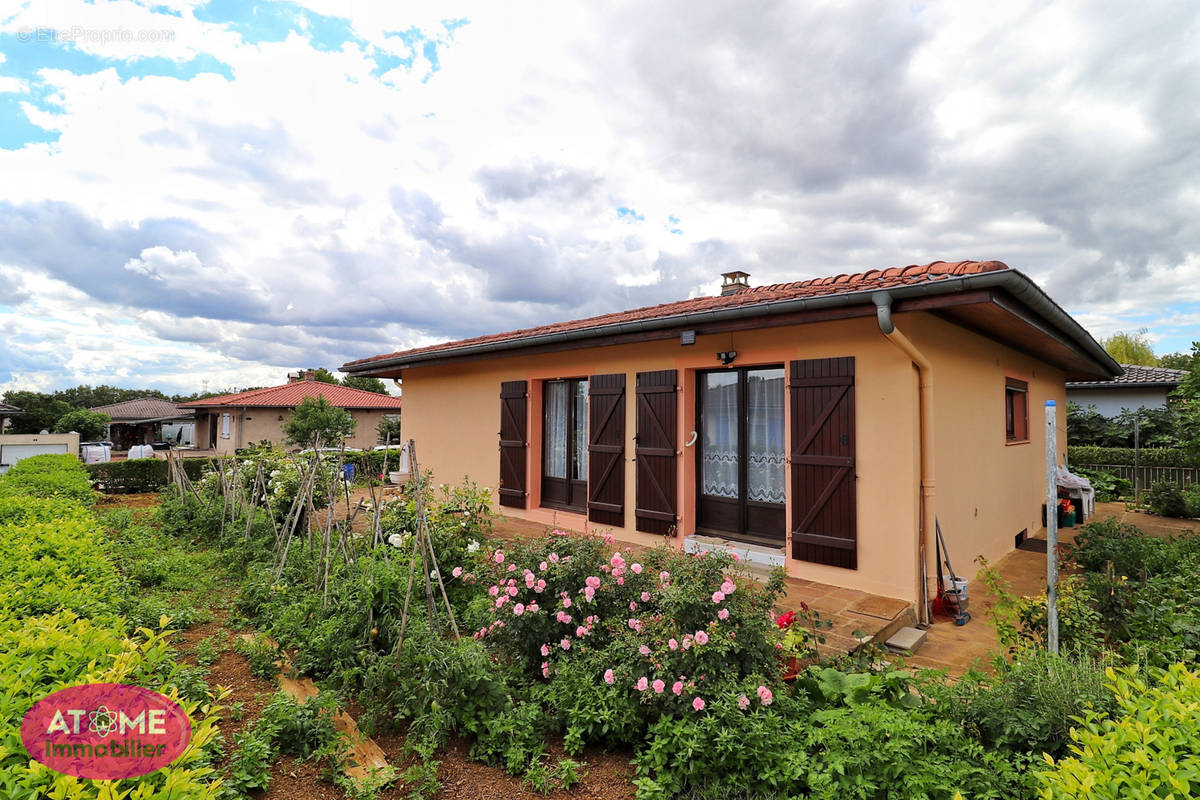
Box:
[180,372,401,453]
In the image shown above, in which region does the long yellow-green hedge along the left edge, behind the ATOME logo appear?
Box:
[0,456,218,800]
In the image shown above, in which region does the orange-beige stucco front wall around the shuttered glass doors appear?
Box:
[403,317,919,600]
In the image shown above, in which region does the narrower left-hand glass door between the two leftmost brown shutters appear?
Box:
[541,379,588,513]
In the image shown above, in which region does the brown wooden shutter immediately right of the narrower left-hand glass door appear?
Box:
[588,374,625,528]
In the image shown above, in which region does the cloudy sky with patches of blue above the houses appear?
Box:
[0,0,1200,392]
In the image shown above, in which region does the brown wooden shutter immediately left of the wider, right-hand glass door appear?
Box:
[634,369,679,534]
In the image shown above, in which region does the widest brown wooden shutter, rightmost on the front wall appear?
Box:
[787,357,858,570]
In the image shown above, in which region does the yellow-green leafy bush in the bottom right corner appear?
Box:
[1038,664,1200,800]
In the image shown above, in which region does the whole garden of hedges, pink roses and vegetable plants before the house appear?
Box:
[0,447,1200,800]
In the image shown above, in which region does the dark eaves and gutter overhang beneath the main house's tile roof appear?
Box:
[341,269,1122,380]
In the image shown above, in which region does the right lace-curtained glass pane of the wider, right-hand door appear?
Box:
[746,368,786,503]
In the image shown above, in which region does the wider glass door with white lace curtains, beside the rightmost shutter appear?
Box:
[696,367,787,545]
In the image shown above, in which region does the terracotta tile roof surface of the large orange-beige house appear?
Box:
[346,261,1008,366]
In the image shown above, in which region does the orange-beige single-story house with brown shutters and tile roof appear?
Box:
[342,261,1121,612]
